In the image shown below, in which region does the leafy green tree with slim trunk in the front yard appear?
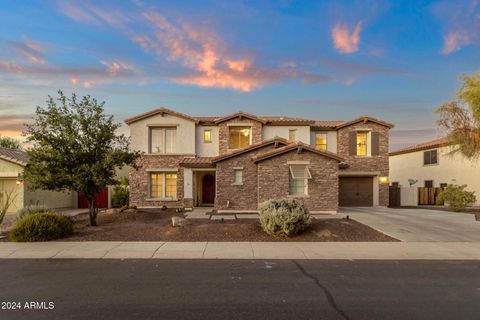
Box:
[24,91,140,226]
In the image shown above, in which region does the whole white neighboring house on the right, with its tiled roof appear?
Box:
[389,138,480,204]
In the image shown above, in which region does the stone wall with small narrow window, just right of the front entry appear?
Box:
[215,145,274,210]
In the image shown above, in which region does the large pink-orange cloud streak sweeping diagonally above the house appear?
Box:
[52,3,331,92]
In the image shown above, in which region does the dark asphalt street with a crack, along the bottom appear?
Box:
[0,260,480,320]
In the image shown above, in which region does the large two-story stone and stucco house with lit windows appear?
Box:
[125,108,393,212]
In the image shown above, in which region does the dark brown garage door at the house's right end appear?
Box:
[338,177,373,207]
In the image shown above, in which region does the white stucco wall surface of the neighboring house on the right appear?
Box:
[389,147,480,205]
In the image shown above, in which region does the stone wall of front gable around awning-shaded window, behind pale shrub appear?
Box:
[258,150,338,211]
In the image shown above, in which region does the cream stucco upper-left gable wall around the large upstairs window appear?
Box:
[130,114,195,155]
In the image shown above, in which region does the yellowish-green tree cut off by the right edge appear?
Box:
[436,72,480,158]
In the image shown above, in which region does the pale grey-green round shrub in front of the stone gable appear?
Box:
[259,199,310,237]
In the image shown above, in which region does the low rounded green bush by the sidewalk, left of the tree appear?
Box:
[9,212,73,242]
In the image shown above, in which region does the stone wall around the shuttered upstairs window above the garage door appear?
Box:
[337,122,389,206]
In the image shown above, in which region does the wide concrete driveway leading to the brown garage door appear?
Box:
[340,207,480,242]
